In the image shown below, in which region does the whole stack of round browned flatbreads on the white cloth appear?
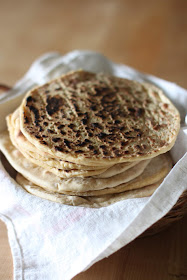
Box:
[0,70,180,207]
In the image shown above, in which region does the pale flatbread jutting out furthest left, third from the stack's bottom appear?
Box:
[0,132,150,193]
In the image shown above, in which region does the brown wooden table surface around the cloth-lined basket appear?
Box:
[0,0,187,280]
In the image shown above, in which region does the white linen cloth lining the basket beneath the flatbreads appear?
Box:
[0,51,187,280]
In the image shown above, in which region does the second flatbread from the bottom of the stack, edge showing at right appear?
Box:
[24,154,172,197]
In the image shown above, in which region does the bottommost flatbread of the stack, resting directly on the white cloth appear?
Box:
[16,173,162,208]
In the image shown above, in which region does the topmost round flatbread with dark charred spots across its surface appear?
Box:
[20,70,180,166]
